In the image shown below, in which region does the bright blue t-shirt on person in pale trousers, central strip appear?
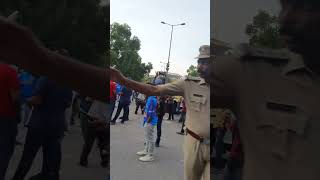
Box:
[143,96,158,125]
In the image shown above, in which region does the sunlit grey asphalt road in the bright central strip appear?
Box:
[110,105,183,180]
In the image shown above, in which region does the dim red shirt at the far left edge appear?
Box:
[0,63,20,118]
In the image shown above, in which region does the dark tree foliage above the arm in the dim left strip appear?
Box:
[0,0,110,66]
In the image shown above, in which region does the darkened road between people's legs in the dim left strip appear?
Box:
[7,122,107,180]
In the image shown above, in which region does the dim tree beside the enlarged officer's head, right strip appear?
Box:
[246,10,284,49]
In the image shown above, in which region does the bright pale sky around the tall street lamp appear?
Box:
[110,0,210,75]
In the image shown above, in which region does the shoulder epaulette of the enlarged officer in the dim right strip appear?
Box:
[236,44,290,61]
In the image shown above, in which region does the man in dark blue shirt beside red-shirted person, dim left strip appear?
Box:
[13,77,72,180]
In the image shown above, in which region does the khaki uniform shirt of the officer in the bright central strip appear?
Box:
[158,77,210,138]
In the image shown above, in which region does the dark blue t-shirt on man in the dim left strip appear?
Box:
[29,77,72,135]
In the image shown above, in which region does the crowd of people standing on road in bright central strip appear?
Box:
[110,81,186,161]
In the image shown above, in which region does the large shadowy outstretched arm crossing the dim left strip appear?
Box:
[0,18,109,101]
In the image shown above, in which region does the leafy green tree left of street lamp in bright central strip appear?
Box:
[110,23,152,81]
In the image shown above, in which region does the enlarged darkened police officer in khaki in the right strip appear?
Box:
[207,0,320,180]
